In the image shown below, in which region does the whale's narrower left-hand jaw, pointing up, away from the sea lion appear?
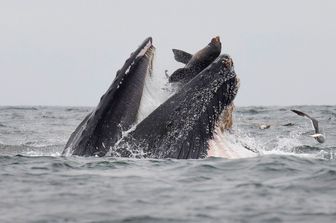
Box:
[63,37,155,156]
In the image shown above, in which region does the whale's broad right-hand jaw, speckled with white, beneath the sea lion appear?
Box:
[114,55,239,159]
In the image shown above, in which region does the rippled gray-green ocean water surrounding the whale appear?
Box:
[0,106,336,222]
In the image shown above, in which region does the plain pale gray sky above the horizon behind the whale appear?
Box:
[0,0,336,106]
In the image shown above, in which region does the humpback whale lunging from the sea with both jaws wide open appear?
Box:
[63,38,239,159]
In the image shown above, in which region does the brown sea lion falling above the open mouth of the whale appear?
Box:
[169,36,222,84]
